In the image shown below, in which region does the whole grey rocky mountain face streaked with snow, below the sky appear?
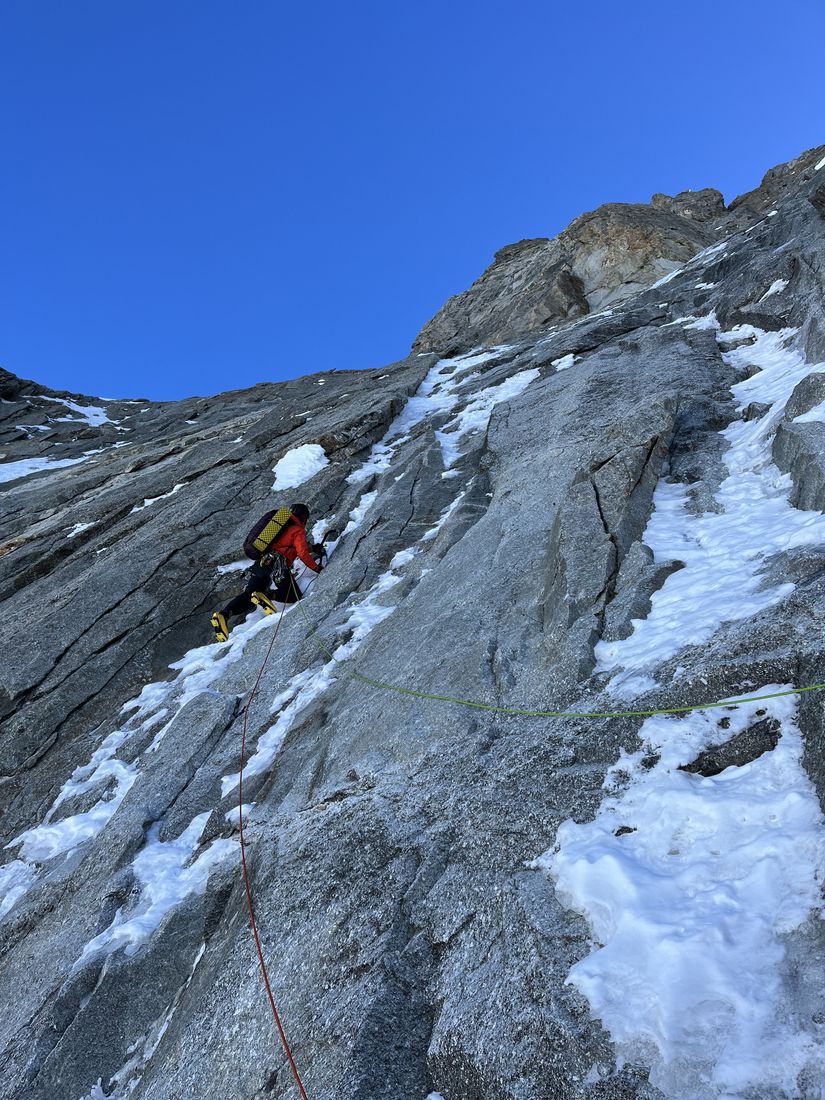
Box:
[0,146,825,1100]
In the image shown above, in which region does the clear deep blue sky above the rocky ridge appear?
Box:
[0,0,825,398]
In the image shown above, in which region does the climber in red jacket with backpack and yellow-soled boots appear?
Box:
[209,504,325,641]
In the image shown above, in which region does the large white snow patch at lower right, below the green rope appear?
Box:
[543,685,825,1100]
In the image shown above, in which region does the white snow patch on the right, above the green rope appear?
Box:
[595,319,825,699]
